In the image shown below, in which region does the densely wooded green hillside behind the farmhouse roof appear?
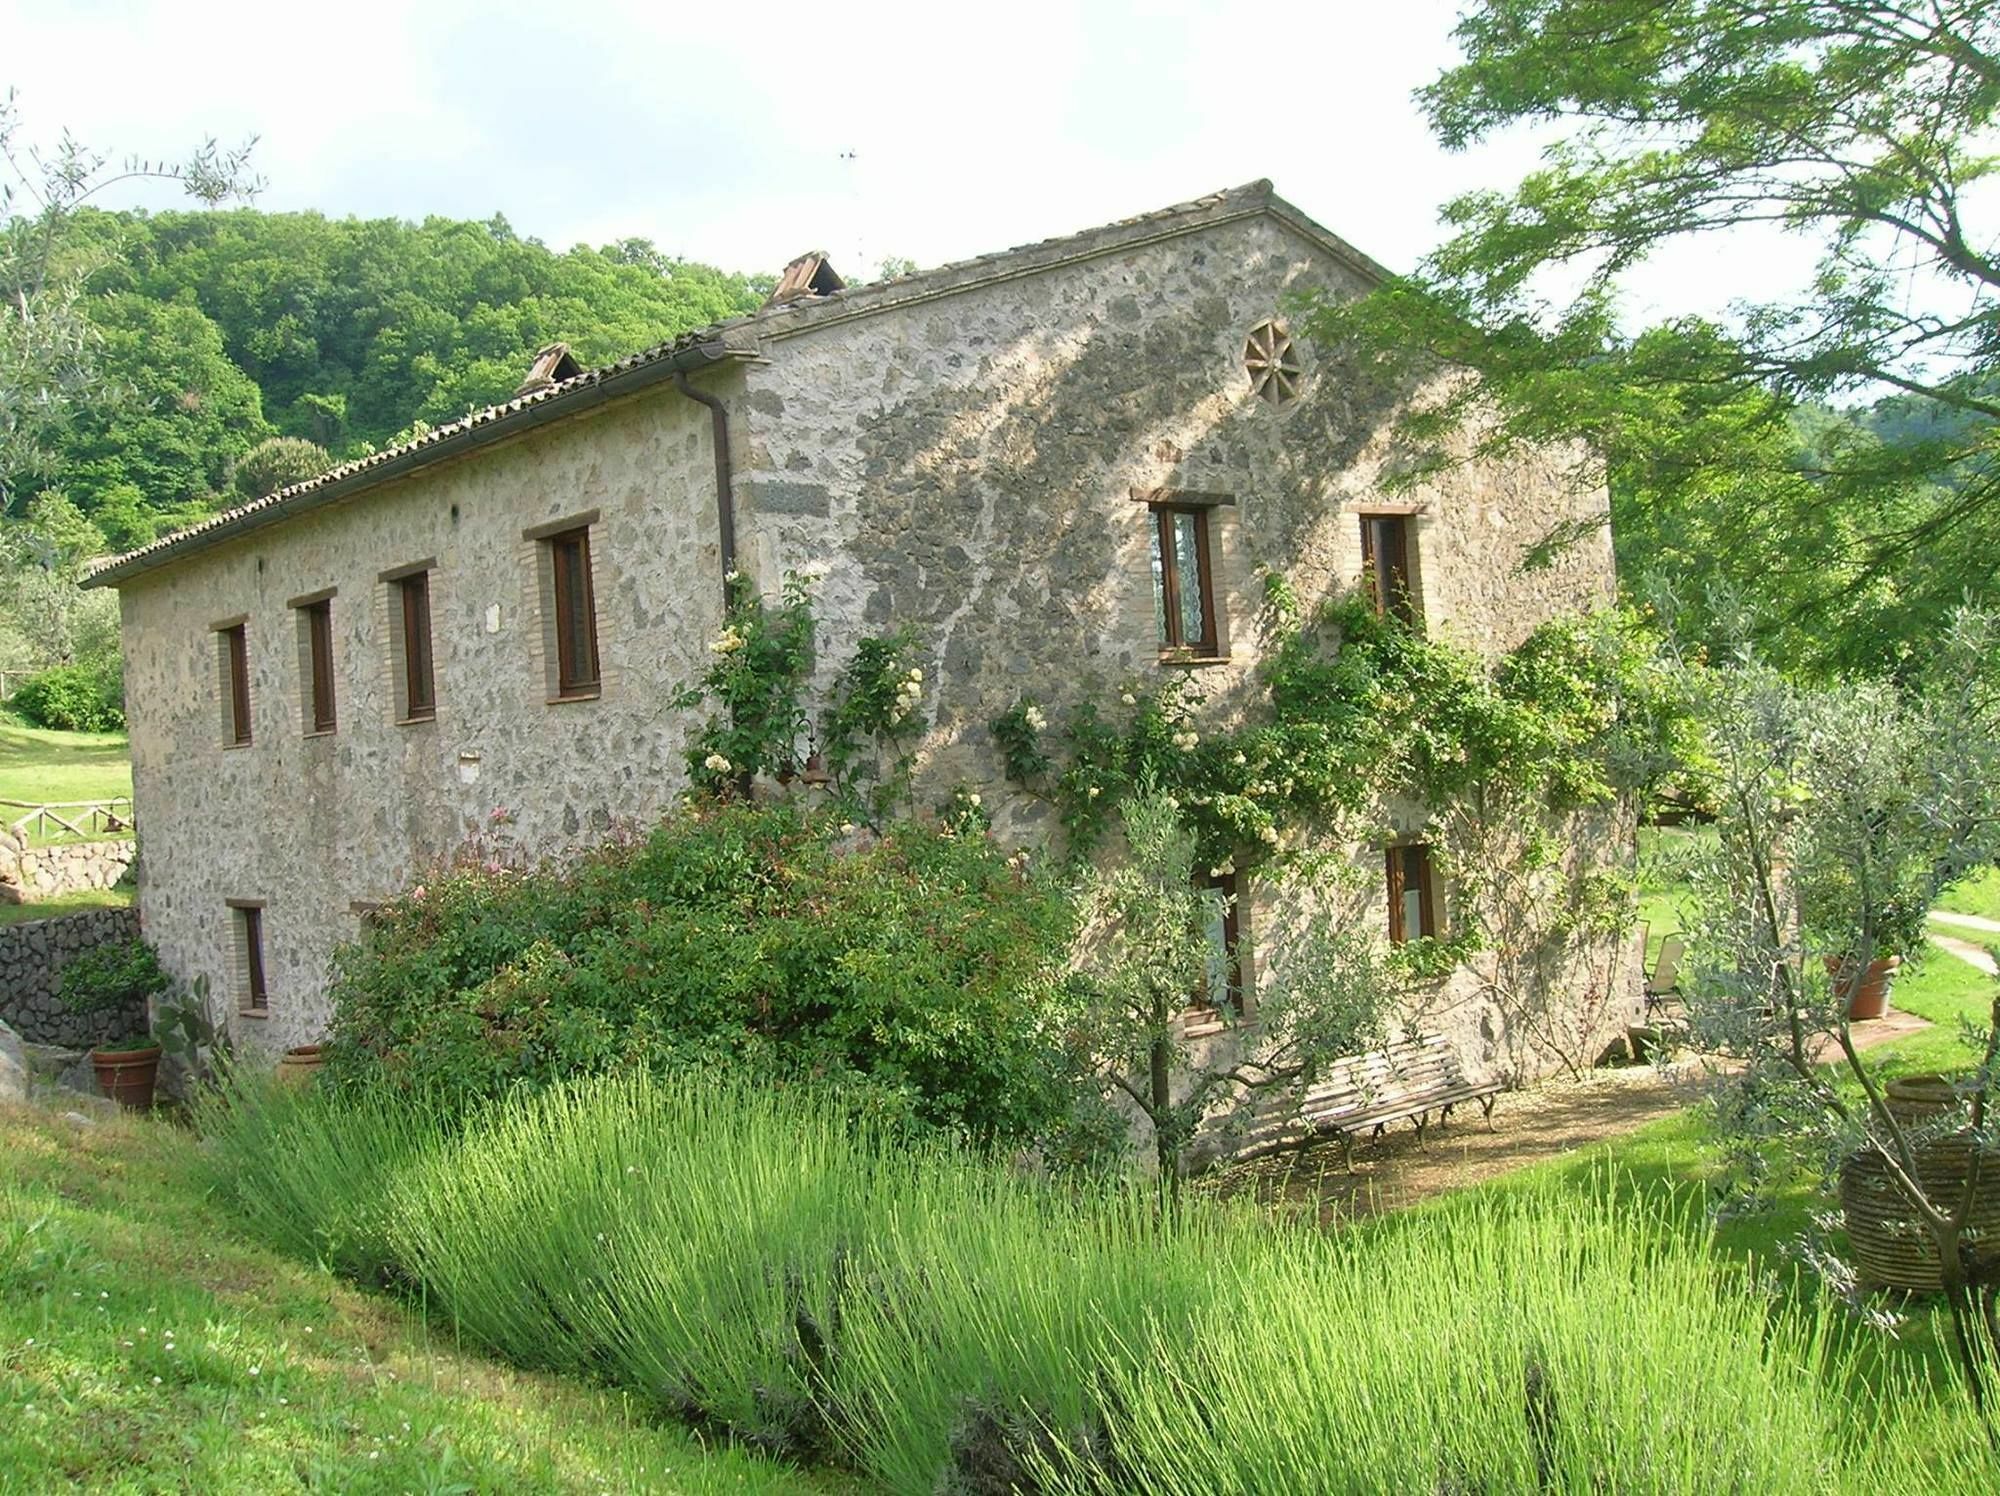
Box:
[54,208,768,548]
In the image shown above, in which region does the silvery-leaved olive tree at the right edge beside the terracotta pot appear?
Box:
[1686,610,2000,1408]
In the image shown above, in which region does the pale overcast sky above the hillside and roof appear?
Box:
[0,0,1800,310]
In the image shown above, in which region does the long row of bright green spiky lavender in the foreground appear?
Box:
[210,1072,1996,1496]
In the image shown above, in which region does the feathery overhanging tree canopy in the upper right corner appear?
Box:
[1314,0,2000,668]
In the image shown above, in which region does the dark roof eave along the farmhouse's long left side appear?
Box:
[82,340,756,588]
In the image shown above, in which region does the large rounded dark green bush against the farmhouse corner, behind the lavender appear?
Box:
[328,804,1074,1144]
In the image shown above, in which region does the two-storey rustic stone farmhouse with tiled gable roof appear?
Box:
[90,182,1630,1068]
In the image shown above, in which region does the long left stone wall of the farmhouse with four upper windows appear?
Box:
[120,390,722,1052]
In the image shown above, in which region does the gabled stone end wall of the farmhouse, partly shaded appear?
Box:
[738,205,1636,1078]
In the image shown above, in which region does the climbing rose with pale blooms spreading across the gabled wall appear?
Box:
[992,576,1694,866]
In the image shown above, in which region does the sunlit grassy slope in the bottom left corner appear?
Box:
[0,1106,828,1492]
